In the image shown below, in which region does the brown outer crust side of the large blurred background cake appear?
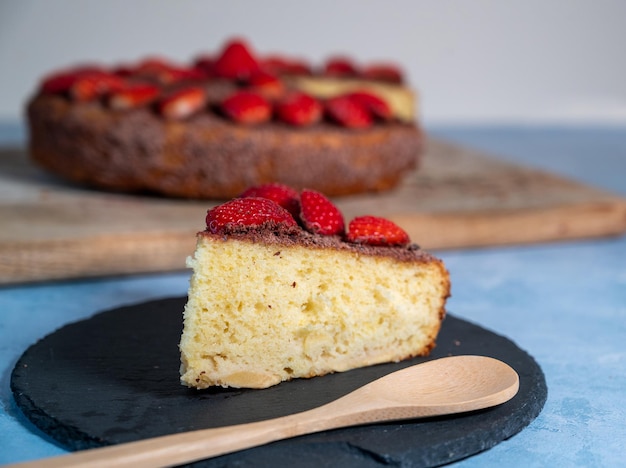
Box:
[27,95,424,199]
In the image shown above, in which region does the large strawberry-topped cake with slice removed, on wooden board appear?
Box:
[27,39,423,199]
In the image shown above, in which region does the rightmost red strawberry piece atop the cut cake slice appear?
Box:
[347,216,410,246]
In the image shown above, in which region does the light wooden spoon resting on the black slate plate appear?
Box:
[8,356,519,468]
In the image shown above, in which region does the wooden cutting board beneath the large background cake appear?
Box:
[0,140,626,284]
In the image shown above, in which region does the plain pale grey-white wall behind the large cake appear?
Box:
[0,0,626,125]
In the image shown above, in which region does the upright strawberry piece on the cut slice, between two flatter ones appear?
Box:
[300,189,345,236]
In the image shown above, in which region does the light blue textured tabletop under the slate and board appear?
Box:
[0,127,626,467]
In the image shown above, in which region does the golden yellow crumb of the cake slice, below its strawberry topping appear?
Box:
[180,235,450,389]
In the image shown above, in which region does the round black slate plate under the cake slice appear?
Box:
[11,297,547,468]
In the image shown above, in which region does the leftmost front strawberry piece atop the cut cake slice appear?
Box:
[206,197,297,234]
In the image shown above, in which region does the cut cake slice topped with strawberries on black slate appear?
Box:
[180,184,450,389]
